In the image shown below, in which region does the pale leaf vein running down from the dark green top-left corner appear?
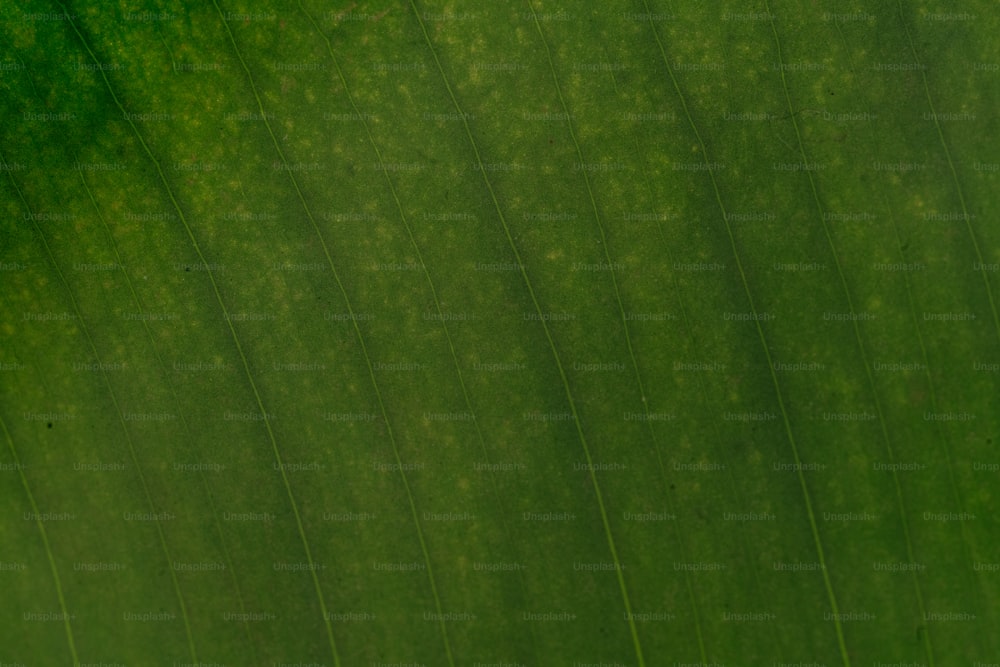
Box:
[57,0,340,667]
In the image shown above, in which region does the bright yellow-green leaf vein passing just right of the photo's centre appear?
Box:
[410,0,646,667]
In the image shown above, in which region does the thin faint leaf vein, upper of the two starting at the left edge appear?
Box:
[0,149,198,662]
